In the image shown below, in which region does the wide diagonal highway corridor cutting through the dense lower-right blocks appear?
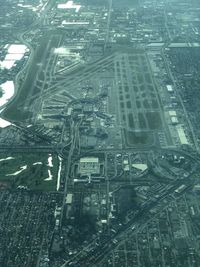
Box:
[62,168,193,267]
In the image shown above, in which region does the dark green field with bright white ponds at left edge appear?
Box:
[0,153,59,191]
